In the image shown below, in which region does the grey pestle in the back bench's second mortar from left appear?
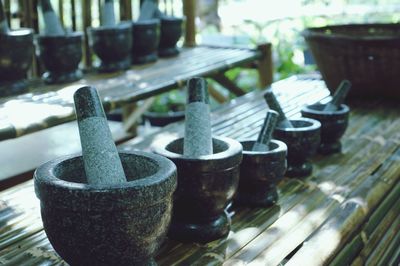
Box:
[40,0,65,36]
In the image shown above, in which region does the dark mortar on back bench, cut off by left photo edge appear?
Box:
[0,28,34,95]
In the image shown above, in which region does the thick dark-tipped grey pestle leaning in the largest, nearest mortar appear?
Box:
[74,86,126,186]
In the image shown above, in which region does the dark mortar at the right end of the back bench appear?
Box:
[158,17,183,57]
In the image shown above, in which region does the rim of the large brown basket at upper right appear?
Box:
[301,23,400,41]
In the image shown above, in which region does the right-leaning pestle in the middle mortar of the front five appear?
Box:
[252,110,279,151]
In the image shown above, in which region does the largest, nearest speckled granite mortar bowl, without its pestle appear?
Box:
[34,152,176,265]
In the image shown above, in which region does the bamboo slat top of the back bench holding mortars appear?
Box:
[0,46,260,141]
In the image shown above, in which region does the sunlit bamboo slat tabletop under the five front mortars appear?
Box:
[0,77,400,265]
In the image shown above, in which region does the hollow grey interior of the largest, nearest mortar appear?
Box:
[54,154,159,183]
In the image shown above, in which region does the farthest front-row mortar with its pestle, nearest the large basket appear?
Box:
[301,80,351,155]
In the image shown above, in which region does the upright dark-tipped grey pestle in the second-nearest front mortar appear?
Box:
[183,78,213,158]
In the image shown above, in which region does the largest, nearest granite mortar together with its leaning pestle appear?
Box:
[34,87,177,265]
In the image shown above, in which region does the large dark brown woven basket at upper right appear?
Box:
[302,24,400,99]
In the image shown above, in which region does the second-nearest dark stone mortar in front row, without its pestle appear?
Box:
[155,137,242,243]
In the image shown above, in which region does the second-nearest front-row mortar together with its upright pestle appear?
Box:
[154,78,242,243]
